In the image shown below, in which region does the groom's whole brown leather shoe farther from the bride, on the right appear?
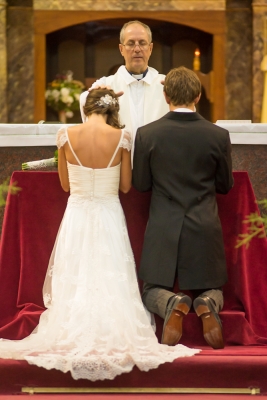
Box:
[193,295,224,349]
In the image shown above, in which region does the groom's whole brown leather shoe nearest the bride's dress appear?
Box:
[161,293,192,346]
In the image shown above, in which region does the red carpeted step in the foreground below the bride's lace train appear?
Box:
[0,347,267,394]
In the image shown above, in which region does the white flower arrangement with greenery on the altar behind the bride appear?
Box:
[45,71,84,118]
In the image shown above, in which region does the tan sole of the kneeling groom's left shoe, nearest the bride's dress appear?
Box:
[161,302,190,346]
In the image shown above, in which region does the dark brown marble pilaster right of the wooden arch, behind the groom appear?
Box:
[225,0,252,120]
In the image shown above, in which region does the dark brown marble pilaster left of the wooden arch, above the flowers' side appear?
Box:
[7,0,34,123]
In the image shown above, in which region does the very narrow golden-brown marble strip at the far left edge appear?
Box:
[0,0,7,123]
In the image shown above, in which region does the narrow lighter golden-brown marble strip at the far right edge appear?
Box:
[252,0,267,122]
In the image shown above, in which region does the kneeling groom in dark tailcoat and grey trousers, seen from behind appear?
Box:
[133,67,233,349]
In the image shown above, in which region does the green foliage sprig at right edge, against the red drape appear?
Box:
[235,199,267,248]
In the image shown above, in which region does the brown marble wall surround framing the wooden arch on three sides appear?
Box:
[0,0,267,123]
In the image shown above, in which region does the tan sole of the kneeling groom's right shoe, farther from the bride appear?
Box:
[195,301,224,349]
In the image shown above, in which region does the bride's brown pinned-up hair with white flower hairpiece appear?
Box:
[83,89,125,129]
